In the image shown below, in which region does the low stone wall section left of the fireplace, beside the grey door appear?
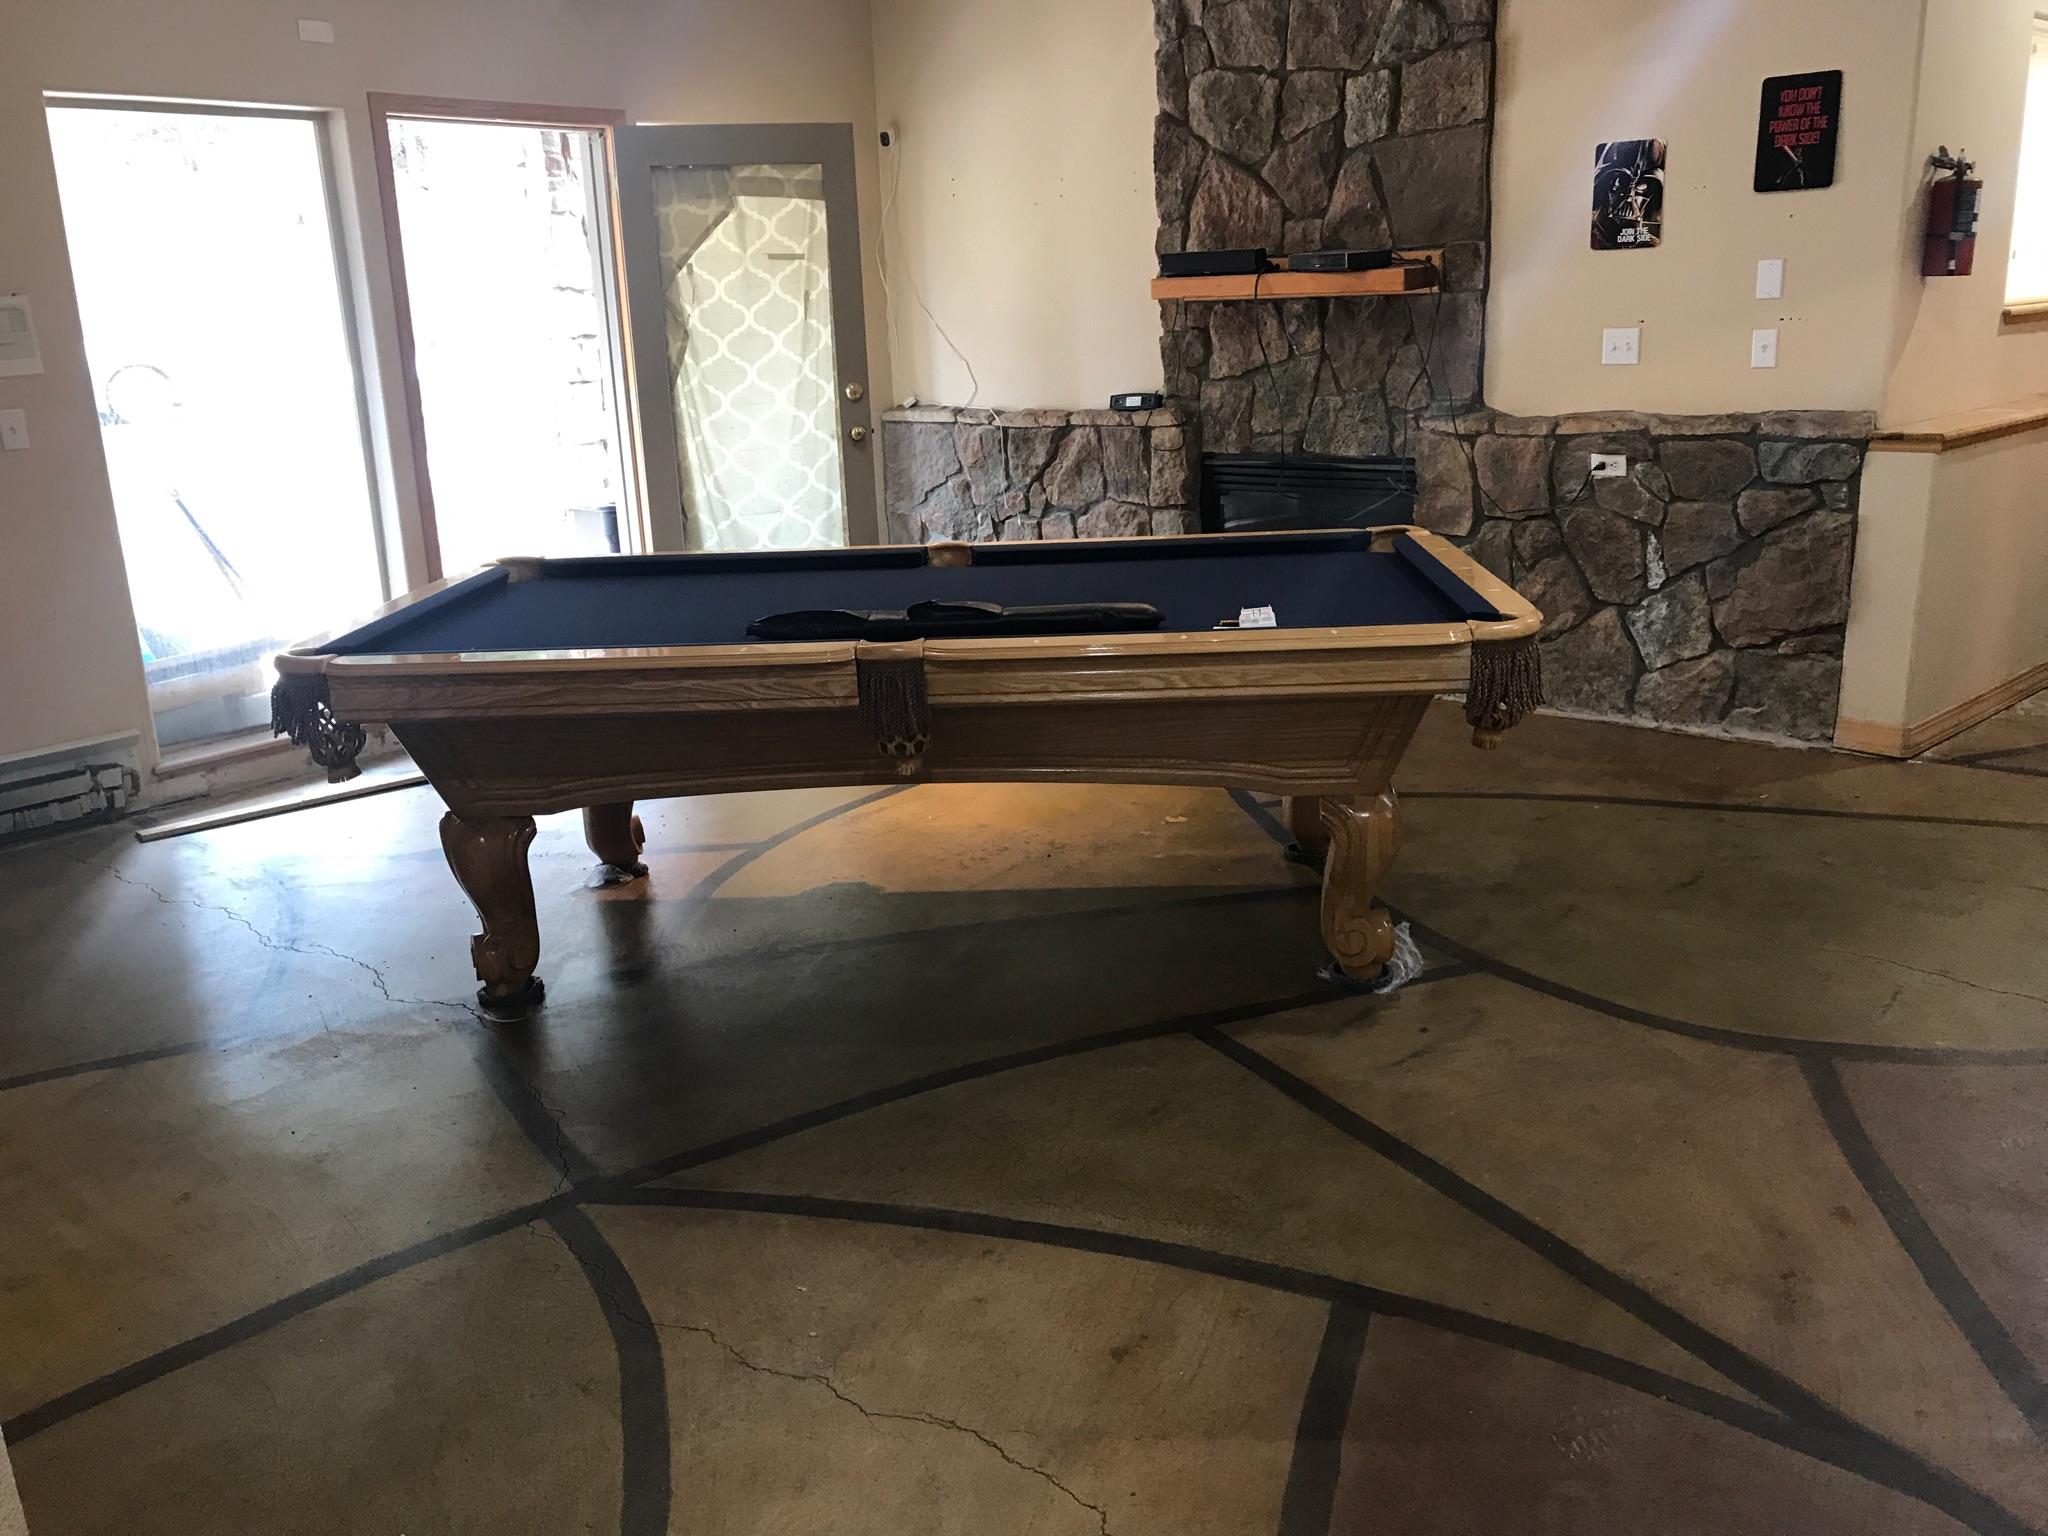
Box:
[883,406,1198,543]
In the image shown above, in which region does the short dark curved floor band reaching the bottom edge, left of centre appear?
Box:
[547,1206,674,1536]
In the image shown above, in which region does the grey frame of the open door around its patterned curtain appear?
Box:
[612,123,883,551]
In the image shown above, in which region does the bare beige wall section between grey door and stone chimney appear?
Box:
[872,0,1161,408]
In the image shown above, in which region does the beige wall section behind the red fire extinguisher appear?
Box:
[1880,0,2048,424]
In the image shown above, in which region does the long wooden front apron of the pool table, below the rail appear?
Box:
[326,627,1468,815]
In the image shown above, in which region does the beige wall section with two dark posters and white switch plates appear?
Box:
[1487,0,1921,416]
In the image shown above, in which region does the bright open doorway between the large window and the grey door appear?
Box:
[371,96,641,578]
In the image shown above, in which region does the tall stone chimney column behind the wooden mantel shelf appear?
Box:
[1153,0,1493,457]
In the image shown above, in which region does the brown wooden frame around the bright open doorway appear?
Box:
[369,90,639,582]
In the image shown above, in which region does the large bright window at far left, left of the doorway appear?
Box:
[49,98,387,748]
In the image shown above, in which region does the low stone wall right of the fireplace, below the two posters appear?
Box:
[1415,412,1872,741]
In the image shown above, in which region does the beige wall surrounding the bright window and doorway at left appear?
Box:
[0,0,887,758]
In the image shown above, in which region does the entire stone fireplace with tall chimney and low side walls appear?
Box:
[883,0,1874,739]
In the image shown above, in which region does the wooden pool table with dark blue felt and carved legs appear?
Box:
[272,528,1540,1016]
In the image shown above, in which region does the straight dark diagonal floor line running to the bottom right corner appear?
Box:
[1196,1032,2028,1530]
